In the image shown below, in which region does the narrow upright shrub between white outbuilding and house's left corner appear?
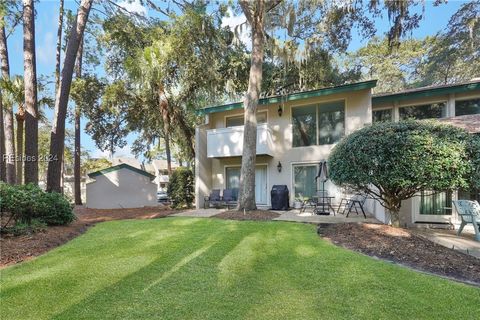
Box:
[167,167,194,208]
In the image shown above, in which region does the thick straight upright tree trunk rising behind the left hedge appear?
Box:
[23,0,38,184]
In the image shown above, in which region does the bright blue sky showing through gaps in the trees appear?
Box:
[3,0,464,157]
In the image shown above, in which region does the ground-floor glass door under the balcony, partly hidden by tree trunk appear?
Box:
[225,165,268,205]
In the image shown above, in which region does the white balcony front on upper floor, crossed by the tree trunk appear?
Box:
[207,123,273,158]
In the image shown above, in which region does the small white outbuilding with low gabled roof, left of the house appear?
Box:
[87,163,158,209]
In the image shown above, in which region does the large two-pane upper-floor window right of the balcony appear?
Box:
[292,101,345,147]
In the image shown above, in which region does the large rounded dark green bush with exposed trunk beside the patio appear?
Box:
[328,120,480,226]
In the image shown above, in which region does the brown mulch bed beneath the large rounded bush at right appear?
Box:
[318,223,480,285]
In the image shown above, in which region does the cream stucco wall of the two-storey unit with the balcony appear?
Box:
[196,89,372,207]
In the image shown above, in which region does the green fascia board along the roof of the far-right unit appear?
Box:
[372,82,480,104]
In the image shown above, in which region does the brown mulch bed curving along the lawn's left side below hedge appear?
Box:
[0,207,178,268]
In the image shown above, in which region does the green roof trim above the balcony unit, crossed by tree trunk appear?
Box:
[197,80,377,115]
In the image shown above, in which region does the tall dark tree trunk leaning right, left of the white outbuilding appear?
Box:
[47,0,93,192]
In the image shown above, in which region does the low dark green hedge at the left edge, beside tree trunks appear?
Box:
[0,183,75,225]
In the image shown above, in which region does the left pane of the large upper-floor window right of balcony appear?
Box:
[292,106,317,147]
